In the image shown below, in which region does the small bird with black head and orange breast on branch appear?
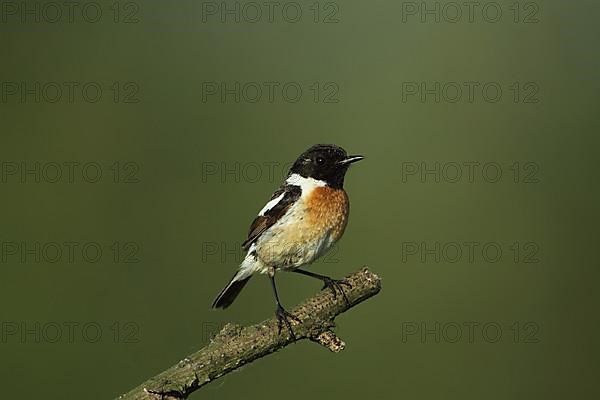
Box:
[212,144,364,340]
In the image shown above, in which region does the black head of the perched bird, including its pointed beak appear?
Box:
[290,144,364,189]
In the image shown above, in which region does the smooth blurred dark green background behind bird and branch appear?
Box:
[0,1,600,400]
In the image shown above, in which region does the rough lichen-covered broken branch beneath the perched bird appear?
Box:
[119,267,381,400]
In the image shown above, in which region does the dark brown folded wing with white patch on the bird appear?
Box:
[242,185,302,250]
